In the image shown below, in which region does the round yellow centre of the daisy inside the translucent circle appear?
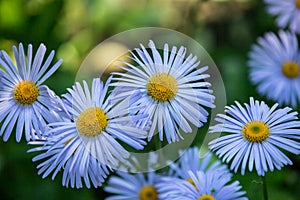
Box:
[147,73,178,101]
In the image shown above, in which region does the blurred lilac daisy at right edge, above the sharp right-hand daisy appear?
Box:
[248,30,300,107]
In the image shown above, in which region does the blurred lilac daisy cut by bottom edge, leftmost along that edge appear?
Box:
[104,171,159,200]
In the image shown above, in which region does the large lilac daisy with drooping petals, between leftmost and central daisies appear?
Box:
[30,77,147,188]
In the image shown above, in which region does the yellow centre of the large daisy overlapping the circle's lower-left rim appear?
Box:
[76,107,108,137]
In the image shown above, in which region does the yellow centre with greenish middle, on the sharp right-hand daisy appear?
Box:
[242,121,270,142]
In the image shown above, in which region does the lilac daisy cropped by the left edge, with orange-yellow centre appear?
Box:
[0,44,62,142]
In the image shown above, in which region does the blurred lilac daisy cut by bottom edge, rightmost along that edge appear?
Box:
[157,171,248,200]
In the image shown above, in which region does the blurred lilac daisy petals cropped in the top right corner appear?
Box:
[264,0,300,33]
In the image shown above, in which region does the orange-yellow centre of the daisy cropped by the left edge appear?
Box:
[13,80,39,105]
